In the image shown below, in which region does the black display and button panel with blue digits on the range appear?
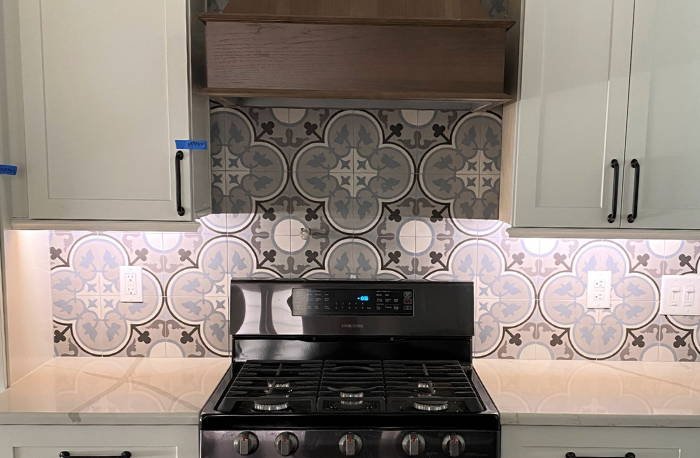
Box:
[292,288,414,316]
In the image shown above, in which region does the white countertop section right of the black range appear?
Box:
[474,359,700,428]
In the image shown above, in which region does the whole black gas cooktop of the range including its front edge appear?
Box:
[201,360,499,430]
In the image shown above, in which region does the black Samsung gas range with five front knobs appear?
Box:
[200,280,500,458]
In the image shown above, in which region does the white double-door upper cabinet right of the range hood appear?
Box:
[504,0,700,237]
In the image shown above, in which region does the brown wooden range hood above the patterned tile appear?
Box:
[199,0,514,109]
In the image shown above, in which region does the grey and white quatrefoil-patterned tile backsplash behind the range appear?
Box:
[48,103,700,361]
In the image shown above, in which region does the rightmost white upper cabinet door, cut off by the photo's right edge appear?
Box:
[623,0,700,229]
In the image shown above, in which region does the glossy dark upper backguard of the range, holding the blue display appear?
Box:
[229,279,474,336]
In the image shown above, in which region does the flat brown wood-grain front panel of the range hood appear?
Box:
[207,22,506,99]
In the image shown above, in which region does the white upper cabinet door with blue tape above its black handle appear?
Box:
[20,0,193,221]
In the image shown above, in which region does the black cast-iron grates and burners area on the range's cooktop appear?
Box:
[216,360,484,415]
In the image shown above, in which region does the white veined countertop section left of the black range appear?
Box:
[0,358,230,425]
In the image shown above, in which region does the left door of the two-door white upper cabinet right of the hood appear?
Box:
[513,0,634,228]
